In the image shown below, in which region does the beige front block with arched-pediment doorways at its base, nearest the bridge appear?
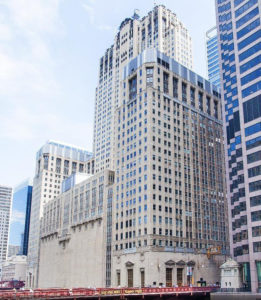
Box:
[112,49,228,286]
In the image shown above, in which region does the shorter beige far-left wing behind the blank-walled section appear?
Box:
[27,141,92,287]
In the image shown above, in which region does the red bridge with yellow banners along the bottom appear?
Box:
[0,287,217,300]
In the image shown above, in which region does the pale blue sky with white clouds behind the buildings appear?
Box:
[0,0,215,187]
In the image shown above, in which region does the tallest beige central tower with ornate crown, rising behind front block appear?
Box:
[93,5,193,172]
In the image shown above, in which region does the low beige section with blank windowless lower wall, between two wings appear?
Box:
[39,170,114,288]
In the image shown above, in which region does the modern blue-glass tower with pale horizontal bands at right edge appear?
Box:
[216,0,261,292]
